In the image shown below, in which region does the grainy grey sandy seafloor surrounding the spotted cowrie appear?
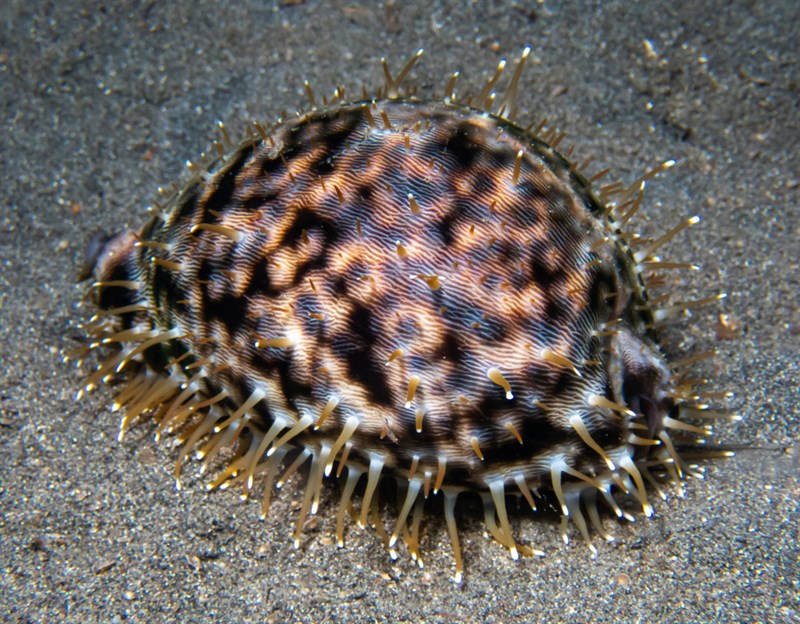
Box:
[0,0,800,623]
